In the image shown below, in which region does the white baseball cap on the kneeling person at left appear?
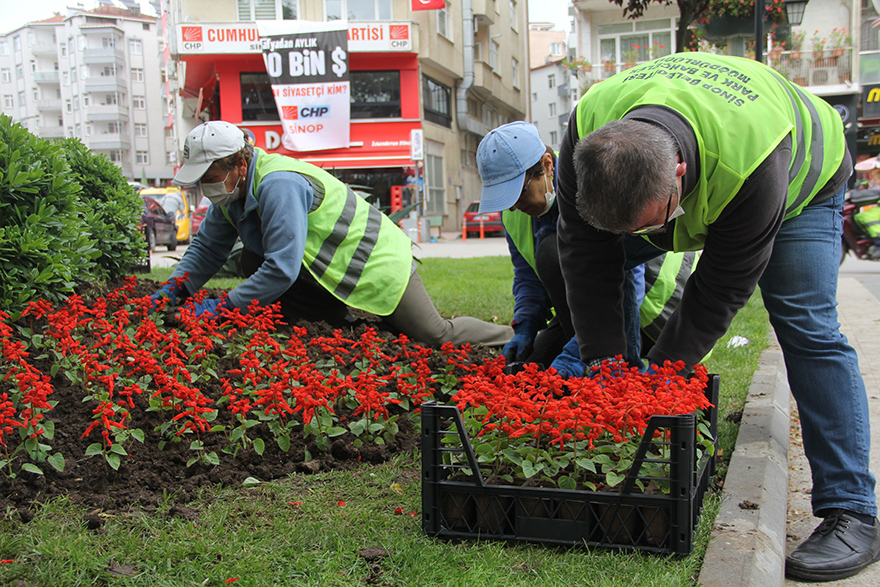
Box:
[171,120,245,185]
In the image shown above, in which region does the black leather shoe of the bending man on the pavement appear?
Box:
[785,510,880,581]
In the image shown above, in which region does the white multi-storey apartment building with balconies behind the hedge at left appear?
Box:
[0,2,175,183]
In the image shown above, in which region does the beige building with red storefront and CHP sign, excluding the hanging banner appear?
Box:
[168,0,528,230]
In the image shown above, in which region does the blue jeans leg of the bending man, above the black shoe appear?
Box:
[758,190,877,515]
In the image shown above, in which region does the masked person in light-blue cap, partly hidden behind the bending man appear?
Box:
[477,121,695,375]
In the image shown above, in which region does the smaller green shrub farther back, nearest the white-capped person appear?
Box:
[62,139,146,279]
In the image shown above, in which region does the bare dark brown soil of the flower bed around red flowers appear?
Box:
[0,280,494,517]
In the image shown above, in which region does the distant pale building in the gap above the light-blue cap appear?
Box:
[529,22,580,151]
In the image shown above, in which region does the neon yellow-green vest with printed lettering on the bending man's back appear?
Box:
[577,53,846,251]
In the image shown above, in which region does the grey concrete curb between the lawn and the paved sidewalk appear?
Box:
[698,344,790,587]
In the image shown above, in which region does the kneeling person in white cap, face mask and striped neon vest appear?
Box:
[153,120,513,346]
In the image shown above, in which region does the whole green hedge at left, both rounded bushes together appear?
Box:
[0,115,144,314]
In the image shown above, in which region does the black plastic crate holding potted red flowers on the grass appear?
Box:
[422,375,719,554]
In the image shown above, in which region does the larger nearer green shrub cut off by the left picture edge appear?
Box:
[0,115,100,313]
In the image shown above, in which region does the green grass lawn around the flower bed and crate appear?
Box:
[0,257,769,587]
